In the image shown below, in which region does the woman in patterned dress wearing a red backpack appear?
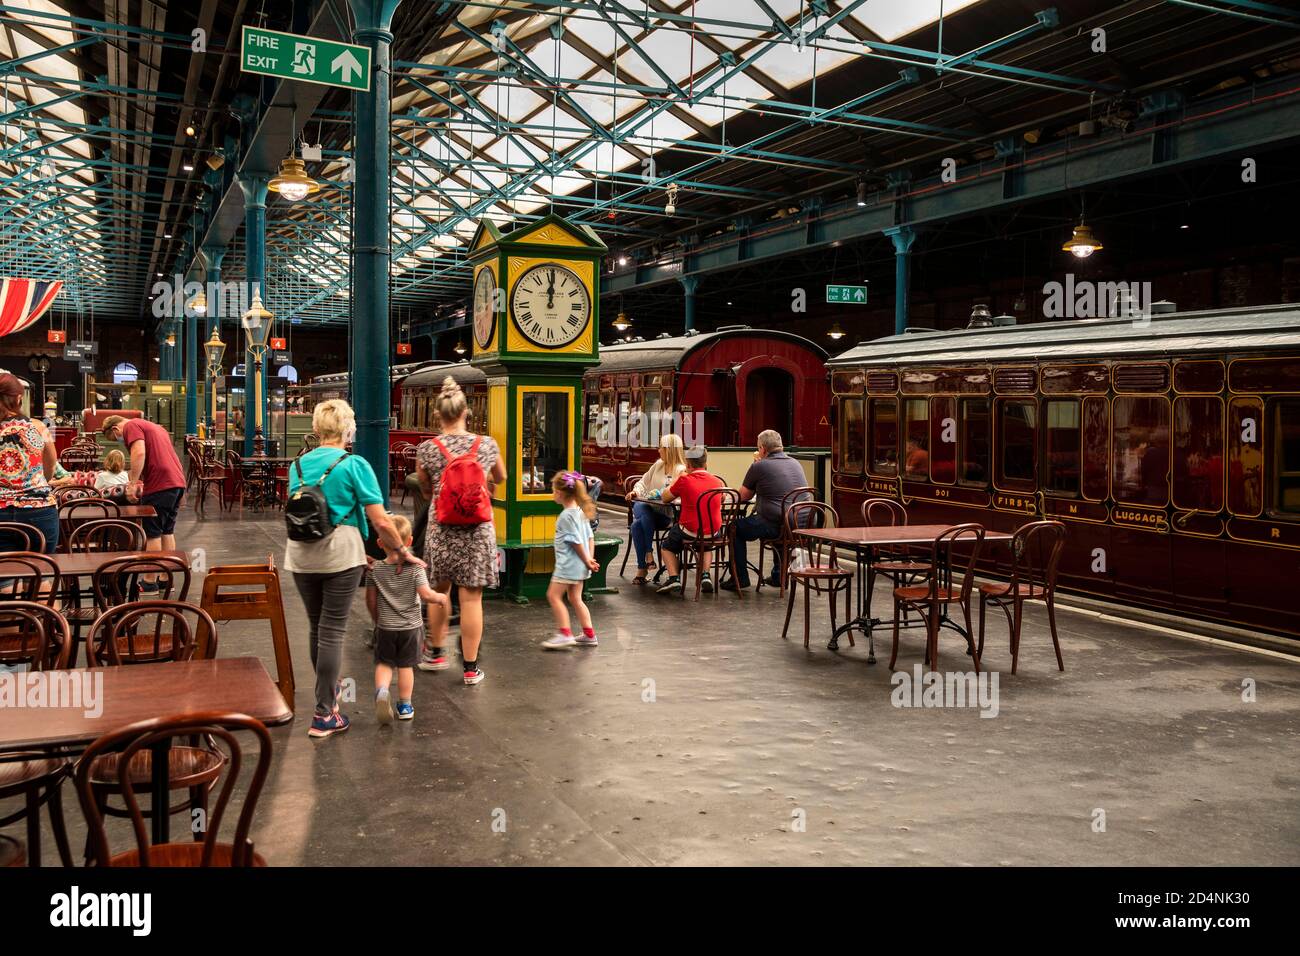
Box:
[416,376,506,684]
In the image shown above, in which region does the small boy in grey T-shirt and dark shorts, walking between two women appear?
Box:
[365,515,447,723]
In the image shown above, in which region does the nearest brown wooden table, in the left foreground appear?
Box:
[0,658,294,844]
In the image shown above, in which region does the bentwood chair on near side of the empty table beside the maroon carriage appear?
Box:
[889,523,984,674]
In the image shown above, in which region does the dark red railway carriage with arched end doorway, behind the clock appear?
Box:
[582,325,831,494]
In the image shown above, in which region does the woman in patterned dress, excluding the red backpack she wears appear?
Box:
[416,376,506,684]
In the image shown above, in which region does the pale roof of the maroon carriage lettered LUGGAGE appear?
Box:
[827,306,1300,368]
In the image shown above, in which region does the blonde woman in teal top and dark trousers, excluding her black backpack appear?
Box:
[285,399,424,737]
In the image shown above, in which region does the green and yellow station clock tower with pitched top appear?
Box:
[468,215,608,597]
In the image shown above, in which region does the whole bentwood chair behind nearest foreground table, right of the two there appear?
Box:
[77,601,226,865]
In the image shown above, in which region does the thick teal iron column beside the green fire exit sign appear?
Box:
[348,0,400,498]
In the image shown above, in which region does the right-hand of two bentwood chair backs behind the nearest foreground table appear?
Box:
[86,601,217,667]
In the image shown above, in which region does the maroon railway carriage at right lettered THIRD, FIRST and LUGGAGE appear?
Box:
[828,306,1300,637]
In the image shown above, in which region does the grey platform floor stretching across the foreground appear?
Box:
[69,507,1300,866]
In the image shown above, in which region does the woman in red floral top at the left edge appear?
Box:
[0,372,59,554]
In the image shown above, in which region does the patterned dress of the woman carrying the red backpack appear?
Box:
[416,434,501,588]
